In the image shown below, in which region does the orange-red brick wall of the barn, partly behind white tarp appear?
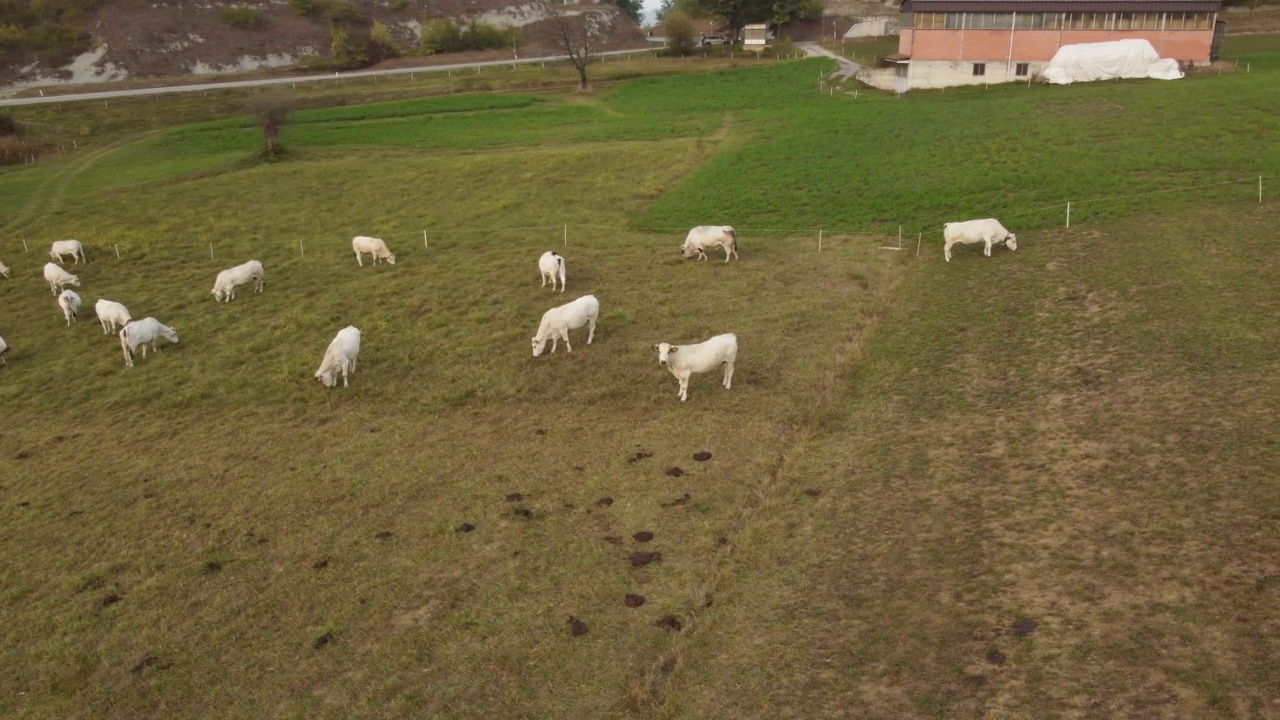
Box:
[897,28,1213,63]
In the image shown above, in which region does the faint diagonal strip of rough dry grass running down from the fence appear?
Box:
[628,262,911,717]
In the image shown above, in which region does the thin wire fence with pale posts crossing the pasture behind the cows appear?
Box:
[0,174,1277,264]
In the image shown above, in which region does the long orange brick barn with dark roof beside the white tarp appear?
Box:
[873,0,1226,92]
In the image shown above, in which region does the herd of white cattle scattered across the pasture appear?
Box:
[0,219,1018,401]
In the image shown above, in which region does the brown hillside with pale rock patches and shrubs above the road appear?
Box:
[0,0,644,88]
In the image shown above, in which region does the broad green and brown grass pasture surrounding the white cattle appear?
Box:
[0,38,1280,719]
